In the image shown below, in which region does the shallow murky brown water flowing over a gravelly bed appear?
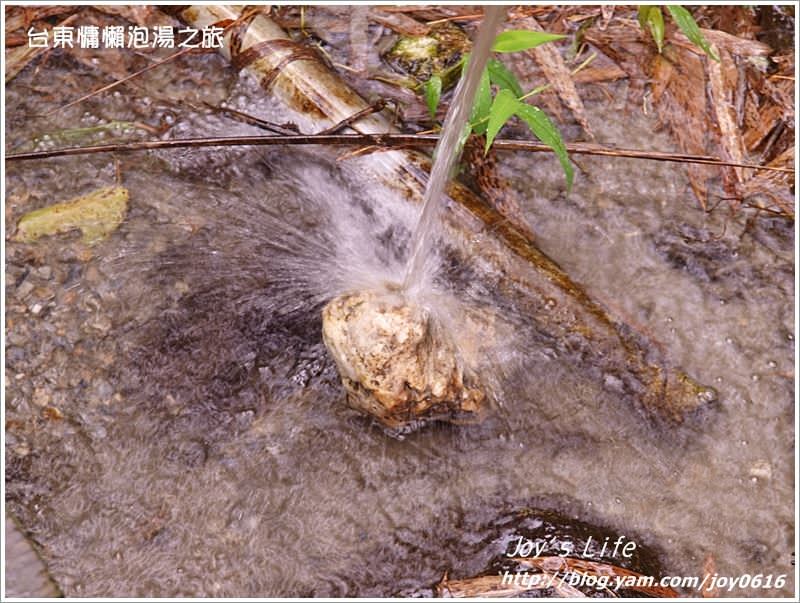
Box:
[6,20,795,597]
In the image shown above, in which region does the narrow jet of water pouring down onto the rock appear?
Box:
[403,6,505,294]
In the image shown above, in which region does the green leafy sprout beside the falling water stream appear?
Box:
[423,30,575,190]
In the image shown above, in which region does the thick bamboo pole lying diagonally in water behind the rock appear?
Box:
[152,5,716,421]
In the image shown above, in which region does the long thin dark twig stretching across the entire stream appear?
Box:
[6,133,794,174]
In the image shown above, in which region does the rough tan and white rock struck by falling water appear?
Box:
[322,291,485,429]
